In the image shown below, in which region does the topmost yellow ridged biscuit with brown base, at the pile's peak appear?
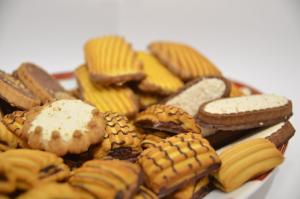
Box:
[84,35,145,86]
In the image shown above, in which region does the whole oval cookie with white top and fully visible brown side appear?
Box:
[197,94,292,130]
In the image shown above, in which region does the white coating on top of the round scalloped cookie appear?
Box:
[29,100,95,142]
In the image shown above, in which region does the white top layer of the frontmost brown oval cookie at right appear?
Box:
[204,94,288,114]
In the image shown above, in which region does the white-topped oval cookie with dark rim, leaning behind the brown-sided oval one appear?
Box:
[164,76,231,116]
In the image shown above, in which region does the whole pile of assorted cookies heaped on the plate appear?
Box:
[0,36,295,199]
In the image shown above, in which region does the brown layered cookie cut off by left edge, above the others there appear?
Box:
[0,70,41,110]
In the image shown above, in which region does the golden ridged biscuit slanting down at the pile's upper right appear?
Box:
[148,41,221,81]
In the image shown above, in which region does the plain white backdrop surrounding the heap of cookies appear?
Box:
[0,0,300,199]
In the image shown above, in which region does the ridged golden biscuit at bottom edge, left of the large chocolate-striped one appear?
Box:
[69,160,141,199]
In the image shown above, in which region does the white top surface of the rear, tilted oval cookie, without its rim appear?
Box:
[167,78,226,116]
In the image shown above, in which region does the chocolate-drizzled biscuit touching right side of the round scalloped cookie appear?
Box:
[94,112,142,159]
